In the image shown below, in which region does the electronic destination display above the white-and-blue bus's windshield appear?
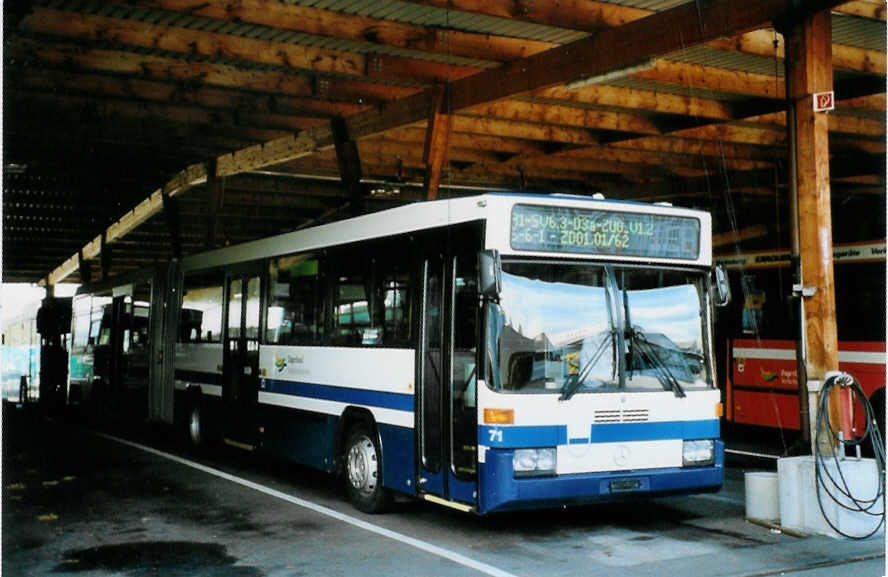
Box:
[511,204,700,260]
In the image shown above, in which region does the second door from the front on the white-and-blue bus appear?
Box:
[222,275,261,450]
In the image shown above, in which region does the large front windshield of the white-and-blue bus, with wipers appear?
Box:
[487,261,712,399]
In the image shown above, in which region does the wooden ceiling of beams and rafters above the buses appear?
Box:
[3,0,886,282]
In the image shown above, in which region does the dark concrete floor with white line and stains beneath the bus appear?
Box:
[2,407,885,577]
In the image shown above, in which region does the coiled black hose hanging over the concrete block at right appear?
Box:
[814,373,885,539]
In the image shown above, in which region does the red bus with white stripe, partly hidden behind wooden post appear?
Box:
[716,240,886,431]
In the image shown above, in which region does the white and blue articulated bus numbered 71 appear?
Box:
[71,194,726,514]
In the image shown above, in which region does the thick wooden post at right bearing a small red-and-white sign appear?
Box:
[788,11,842,450]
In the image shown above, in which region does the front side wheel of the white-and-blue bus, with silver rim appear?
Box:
[343,422,391,513]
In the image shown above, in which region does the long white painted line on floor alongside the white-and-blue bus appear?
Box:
[95,433,516,577]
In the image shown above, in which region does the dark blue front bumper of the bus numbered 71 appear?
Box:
[479,441,725,514]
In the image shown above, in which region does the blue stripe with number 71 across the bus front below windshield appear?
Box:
[478,419,719,448]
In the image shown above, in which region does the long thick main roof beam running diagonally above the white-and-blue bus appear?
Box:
[49,0,838,284]
